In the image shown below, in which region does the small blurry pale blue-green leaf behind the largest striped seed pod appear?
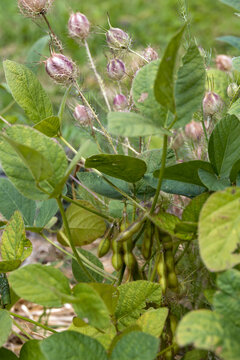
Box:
[26,35,50,73]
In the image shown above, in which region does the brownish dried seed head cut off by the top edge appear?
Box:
[18,0,54,18]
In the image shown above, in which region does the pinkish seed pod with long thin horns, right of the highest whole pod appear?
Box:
[106,27,131,50]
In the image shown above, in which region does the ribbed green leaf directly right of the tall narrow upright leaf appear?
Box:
[175,45,206,127]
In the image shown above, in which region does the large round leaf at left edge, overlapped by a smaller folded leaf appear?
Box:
[0,125,67,200]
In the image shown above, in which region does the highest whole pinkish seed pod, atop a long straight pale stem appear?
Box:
[68,12,90,40]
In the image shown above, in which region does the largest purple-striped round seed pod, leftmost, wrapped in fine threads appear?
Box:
[45,53,77,84]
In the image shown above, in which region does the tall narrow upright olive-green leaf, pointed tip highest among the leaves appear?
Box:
[154,25,185,114]
